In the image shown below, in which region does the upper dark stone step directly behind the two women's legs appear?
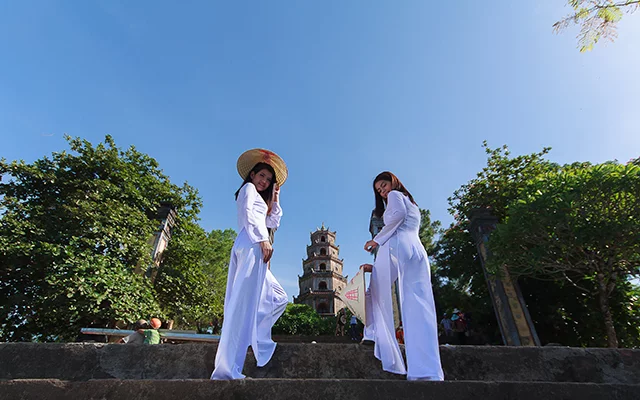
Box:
[0,343,640,382]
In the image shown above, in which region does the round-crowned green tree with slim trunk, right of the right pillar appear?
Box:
[489,163,640,347]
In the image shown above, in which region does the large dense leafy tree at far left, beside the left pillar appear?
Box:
[0,136,201,341]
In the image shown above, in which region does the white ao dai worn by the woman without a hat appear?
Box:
[370,190,444,380]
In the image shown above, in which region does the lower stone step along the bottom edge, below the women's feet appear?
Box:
[0,379,640,400]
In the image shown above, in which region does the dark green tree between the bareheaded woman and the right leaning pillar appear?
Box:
[433,141,558,342]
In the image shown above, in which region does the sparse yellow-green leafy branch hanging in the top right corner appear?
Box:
[553,0,640,52]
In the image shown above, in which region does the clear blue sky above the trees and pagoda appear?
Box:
[0,0,640,297]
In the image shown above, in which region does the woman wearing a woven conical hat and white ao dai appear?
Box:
[211,149,288,379]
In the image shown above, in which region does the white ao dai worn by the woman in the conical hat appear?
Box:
[211,182,287,379]
